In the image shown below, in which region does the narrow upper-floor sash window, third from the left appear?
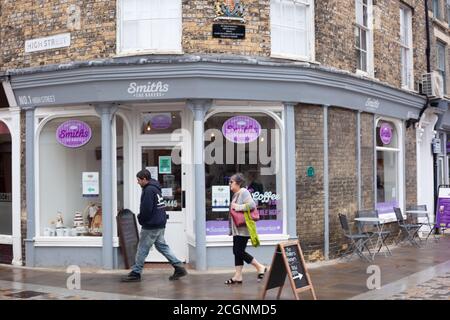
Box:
[355,0,373,75]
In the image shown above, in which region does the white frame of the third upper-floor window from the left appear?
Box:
[355,0,374,77]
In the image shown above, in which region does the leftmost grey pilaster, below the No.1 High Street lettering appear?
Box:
[23,106,36,267]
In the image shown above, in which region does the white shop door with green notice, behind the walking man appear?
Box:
[140,145,187,262]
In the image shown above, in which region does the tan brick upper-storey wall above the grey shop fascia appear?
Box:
[0,0,426,91]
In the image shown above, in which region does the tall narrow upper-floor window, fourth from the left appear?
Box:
[400,6,414,90]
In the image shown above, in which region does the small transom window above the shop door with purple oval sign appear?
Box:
[141,111,181,134]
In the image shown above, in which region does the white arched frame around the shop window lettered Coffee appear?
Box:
[205,103,289,247]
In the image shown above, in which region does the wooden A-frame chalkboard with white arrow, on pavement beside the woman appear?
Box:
[262,241,317,300]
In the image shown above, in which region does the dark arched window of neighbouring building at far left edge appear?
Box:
[0,121,12,235]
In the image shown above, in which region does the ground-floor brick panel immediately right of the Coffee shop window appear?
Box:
[295,105,324,261]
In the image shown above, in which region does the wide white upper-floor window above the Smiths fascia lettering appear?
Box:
[117,0,182,53]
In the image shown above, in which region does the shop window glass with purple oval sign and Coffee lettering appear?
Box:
[205,112,284,236]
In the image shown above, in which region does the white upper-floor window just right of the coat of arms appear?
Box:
[270,0,314,60]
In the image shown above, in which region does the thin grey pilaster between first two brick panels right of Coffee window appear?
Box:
[323,105,330,260]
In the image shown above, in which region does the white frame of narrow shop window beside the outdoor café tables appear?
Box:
[374,117,406,223]
